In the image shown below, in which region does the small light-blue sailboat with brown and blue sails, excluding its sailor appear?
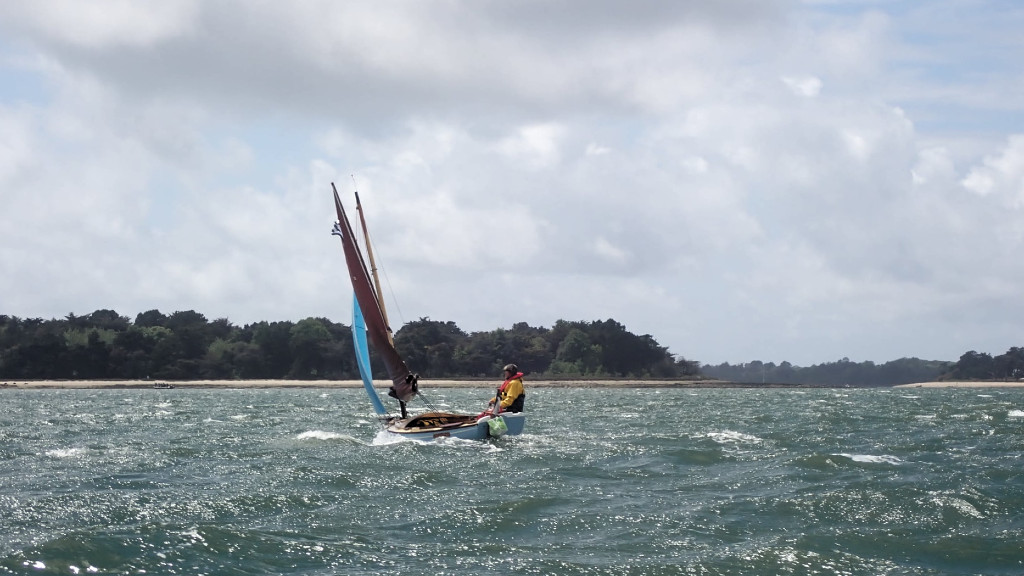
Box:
[331,182,526,441]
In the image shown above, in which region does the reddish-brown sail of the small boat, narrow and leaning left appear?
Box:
[331,182,417,402]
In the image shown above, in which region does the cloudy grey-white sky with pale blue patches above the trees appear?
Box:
[0,0,1024,366]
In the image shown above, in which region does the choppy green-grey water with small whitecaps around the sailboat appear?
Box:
[0,388,1024,575]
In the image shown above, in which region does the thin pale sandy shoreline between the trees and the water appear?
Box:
[0,379,1024,389]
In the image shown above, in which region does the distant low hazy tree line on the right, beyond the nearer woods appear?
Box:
[700,346,1024,386]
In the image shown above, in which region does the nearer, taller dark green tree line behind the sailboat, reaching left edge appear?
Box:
[0,310,698,380]
